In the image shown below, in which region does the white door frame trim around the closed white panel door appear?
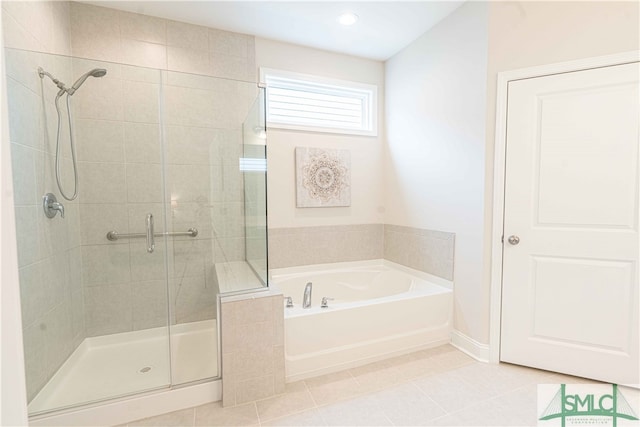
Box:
[489,51,640,363]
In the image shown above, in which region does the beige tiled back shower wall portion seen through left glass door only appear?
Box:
[73,59,167,336]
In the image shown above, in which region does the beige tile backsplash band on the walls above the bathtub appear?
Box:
[269,224,455,280]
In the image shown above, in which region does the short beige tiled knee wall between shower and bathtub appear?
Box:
[222,290,285,408]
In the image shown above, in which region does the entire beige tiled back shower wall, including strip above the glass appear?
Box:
[65,3,255,336]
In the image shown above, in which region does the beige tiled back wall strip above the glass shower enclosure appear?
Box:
[70,2,256,82]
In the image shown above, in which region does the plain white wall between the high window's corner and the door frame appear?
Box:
[384,2,489,342]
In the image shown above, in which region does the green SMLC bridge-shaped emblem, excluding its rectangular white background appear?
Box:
[539,384,638,427]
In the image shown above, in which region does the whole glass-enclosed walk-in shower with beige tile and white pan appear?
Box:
[5,49,267,422]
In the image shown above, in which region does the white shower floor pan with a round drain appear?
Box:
[29,320,218,415]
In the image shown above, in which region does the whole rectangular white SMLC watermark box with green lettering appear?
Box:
[538,384,640,427]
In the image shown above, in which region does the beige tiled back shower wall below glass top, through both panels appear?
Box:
[74,59,255,336]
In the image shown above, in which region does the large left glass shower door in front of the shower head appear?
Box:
[6,49,170,415]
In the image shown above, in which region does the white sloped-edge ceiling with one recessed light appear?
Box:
[87,0,463,60]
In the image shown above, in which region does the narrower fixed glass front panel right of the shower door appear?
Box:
[163,71,261,385]
